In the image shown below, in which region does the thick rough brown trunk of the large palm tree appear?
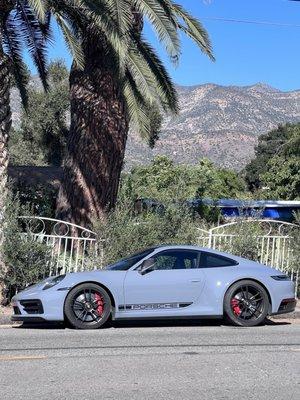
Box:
[57,32,128,233]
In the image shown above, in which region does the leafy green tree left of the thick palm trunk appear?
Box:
[8,61,69,166]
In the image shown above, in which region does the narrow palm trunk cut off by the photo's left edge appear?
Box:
[0,34,11,303]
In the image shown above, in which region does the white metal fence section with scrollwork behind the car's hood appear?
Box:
[19,216,103,275]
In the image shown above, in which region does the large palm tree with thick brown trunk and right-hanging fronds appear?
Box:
[57,0,213,226]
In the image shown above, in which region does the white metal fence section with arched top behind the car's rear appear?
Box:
[197,219,300,287]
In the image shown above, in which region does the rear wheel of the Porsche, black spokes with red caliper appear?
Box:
[224,279,270,327]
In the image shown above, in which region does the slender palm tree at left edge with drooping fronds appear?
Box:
[0,0,115,300]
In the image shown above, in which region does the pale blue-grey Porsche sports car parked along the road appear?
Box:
[12,246,296,329]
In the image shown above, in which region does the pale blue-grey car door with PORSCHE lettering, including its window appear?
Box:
[123,249,205,316]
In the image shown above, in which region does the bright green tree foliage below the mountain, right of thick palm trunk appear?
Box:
[120,156,246,202]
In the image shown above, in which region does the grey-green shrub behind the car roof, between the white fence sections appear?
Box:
[96,203,209,264]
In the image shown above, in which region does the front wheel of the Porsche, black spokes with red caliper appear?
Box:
[64,283,111,329]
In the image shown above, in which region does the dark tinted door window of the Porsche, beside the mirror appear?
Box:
[152,250,200,270]
